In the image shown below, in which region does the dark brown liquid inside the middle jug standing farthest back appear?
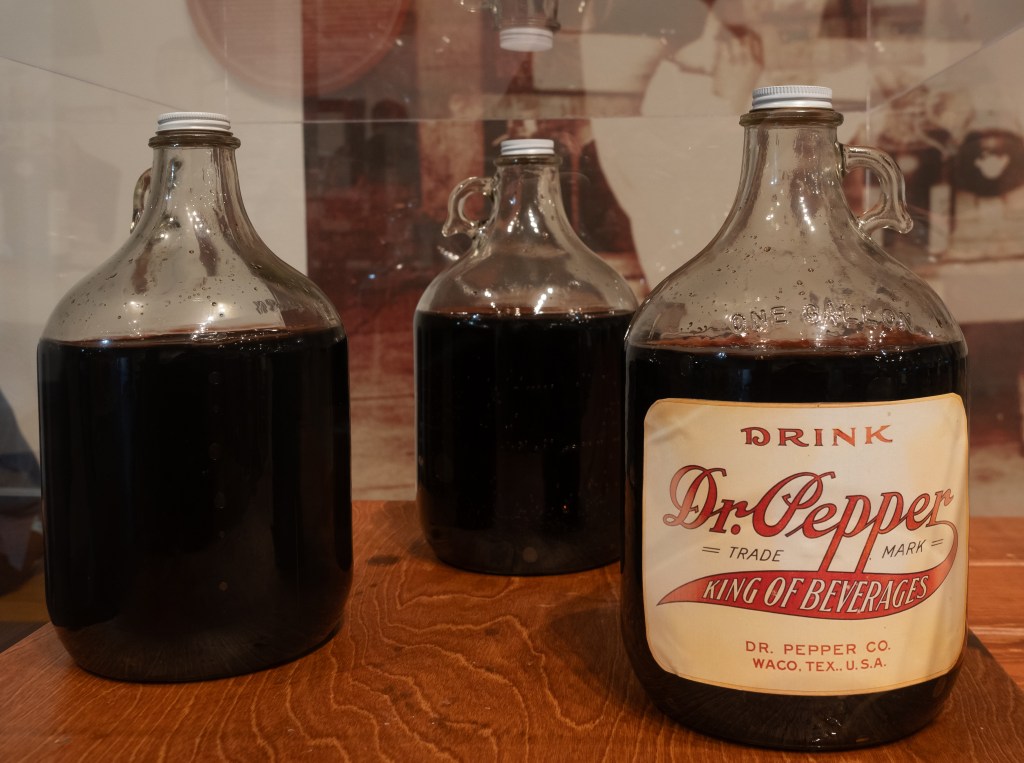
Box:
[416,312,632,575]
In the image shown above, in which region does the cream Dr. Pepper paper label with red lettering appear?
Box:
[642,394,968,694]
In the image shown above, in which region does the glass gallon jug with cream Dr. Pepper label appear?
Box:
[622,86,968,750]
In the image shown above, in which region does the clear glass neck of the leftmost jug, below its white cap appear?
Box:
[137,131,252,239]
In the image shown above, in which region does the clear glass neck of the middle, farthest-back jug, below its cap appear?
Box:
[489,156,575,243]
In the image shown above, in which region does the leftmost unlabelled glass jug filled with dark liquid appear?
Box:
[38,113,352,681]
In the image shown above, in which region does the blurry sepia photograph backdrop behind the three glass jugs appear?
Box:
[0,0,1024,602]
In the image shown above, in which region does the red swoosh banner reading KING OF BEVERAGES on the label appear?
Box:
[657,535,956,620]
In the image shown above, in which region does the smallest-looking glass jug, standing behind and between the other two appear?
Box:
[415,139,636,575]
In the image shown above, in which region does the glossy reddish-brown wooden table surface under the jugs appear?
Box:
[0,502,1024,763]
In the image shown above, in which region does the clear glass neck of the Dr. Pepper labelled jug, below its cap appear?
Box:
[724,109,856,237]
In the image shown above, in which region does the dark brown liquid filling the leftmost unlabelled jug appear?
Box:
[39,329,352,681]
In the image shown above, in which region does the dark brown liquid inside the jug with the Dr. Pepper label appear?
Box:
[622,337,967,750]
